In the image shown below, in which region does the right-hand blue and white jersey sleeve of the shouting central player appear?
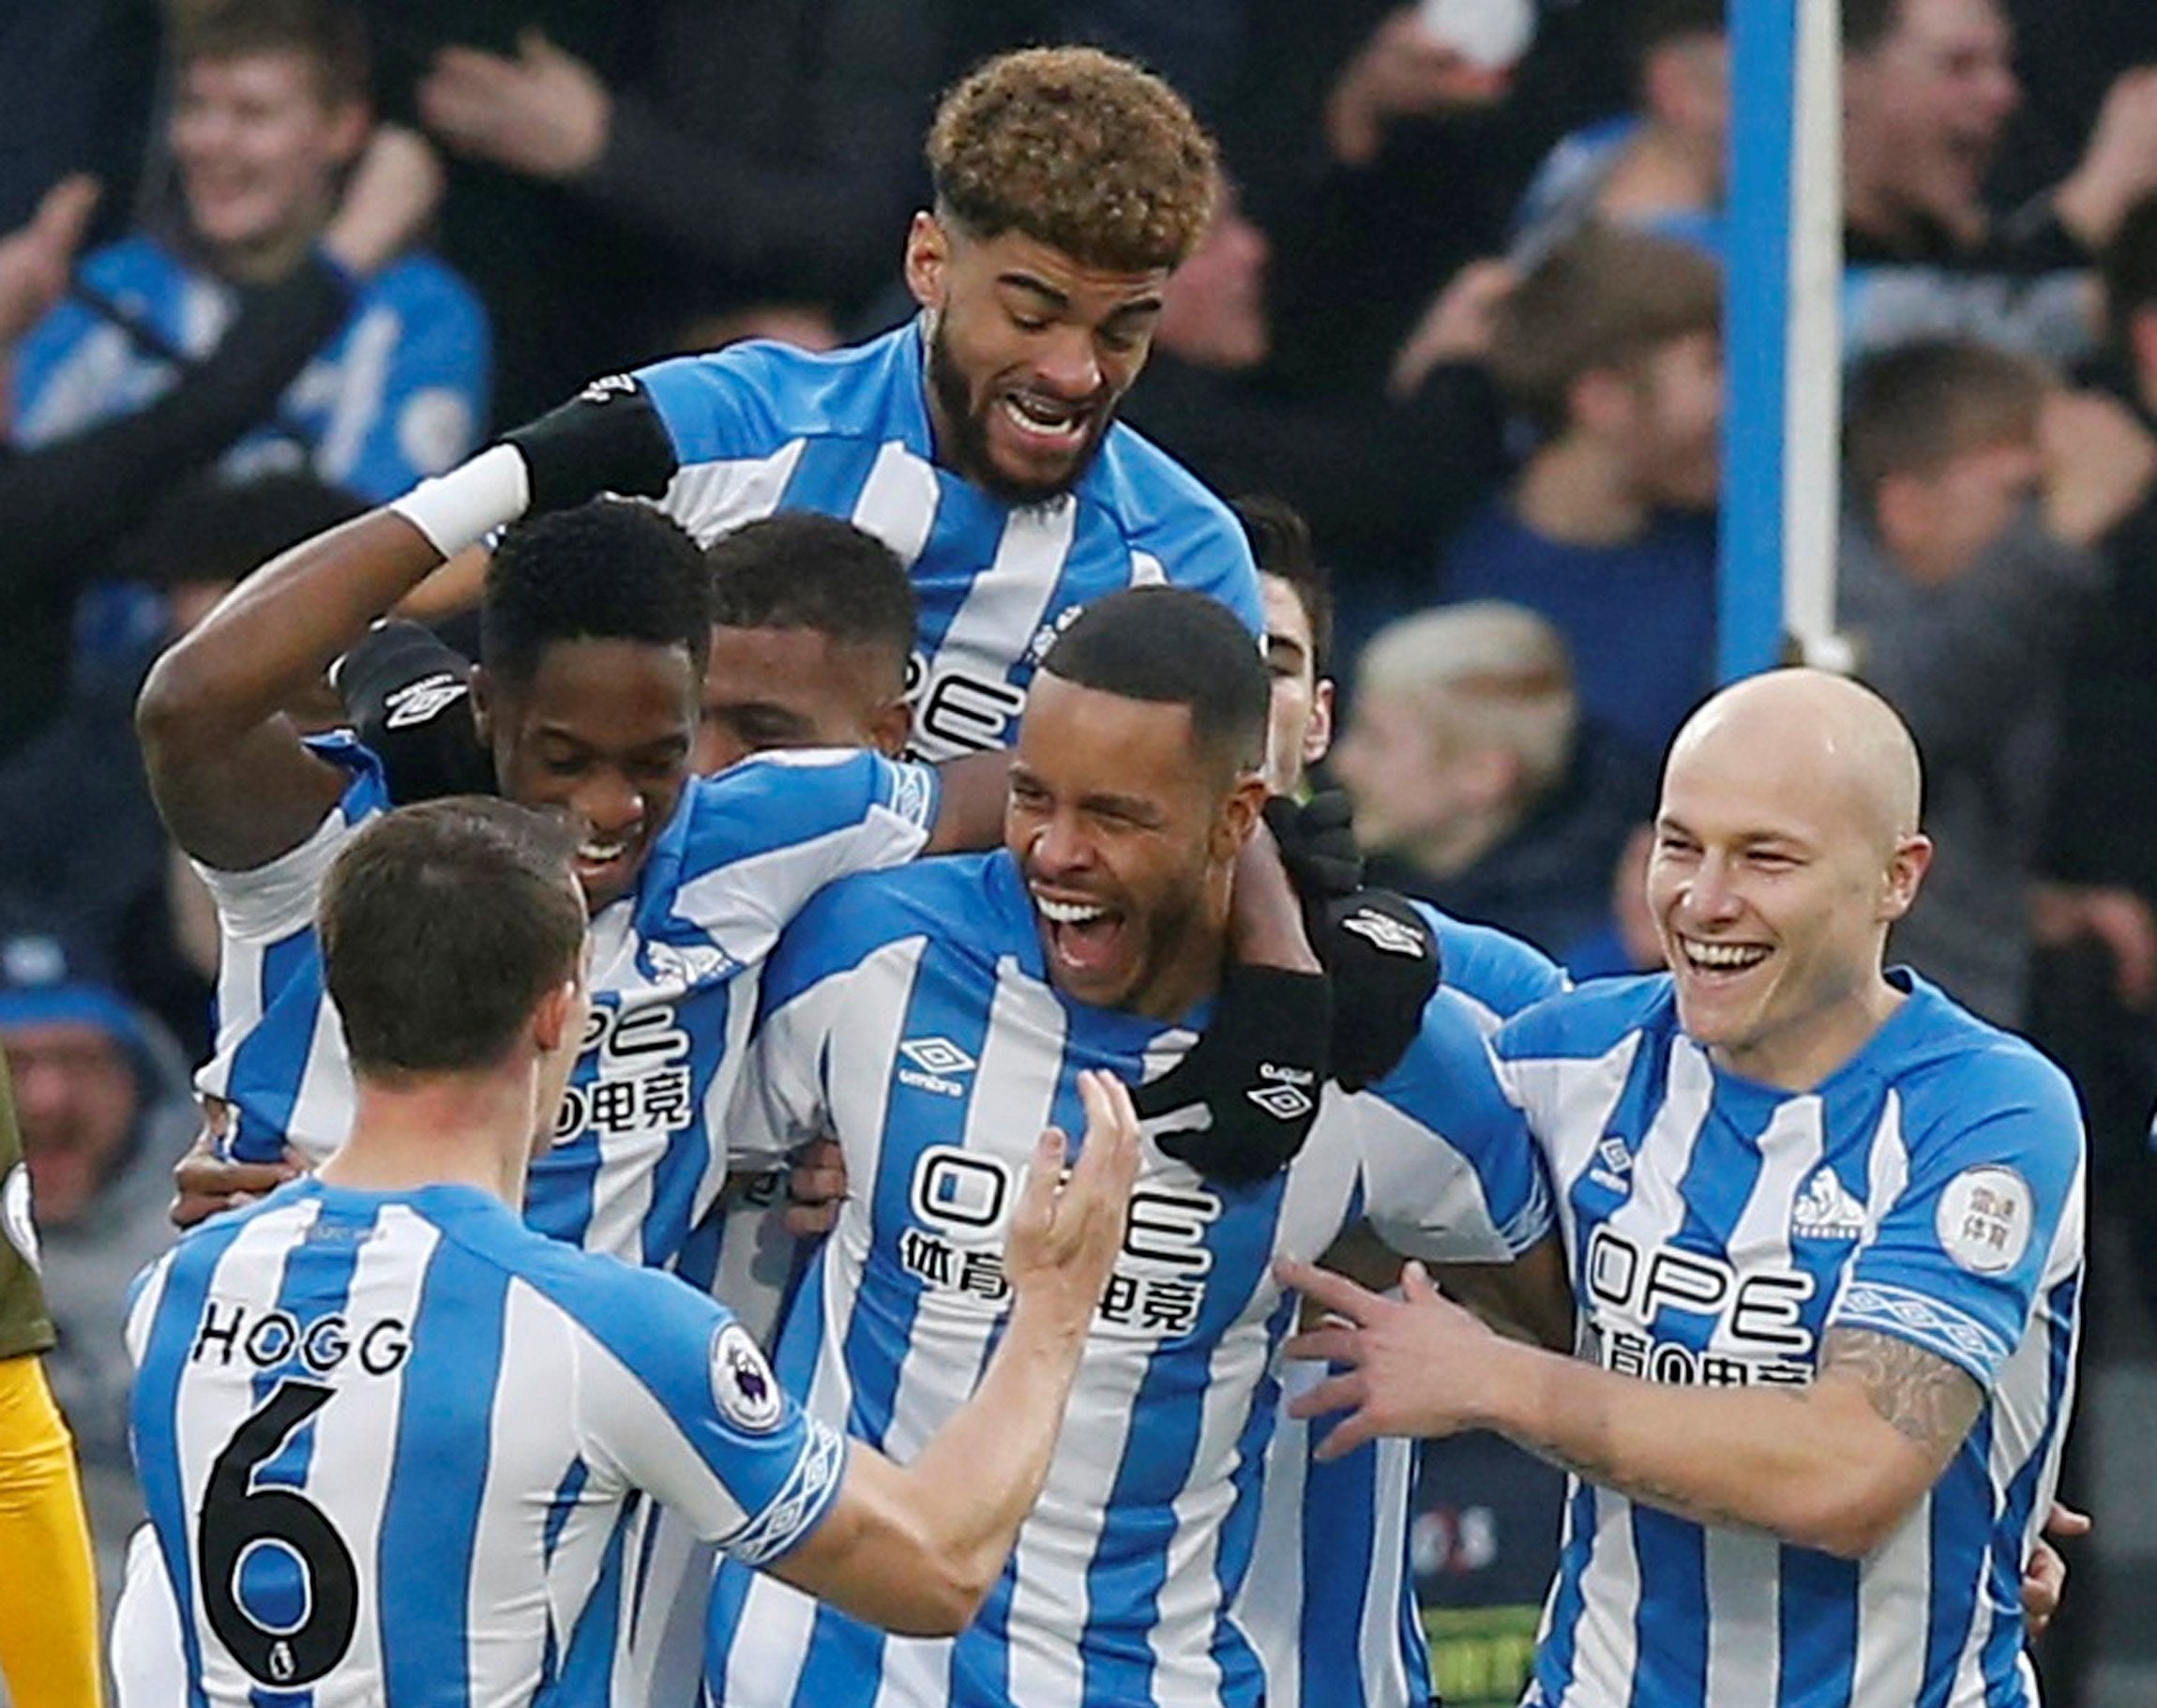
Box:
[1352,990,1553,1263]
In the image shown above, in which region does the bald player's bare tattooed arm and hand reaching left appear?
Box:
[1284,1263,1983,1559]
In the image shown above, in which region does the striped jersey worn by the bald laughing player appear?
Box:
[1493,971,2084,1708]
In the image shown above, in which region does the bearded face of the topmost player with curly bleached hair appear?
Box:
[906,214,1169,505]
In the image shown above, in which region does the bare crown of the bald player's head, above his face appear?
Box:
[1669,671,1924,850]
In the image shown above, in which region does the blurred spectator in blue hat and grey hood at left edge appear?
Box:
[0,936,196,1605]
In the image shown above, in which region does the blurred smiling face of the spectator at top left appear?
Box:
[171,52,367,276]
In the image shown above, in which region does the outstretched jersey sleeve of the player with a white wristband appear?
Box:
[673,748,941,966]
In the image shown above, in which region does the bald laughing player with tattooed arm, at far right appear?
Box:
[1288,671,2084,1708]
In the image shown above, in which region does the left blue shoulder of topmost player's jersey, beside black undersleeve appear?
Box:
[637,324,921,463]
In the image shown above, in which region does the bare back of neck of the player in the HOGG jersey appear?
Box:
[322,1069,537,1210]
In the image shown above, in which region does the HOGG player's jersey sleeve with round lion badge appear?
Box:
[574,1263,846,1565]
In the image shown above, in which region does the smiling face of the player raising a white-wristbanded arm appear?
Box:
[473,641,701,913]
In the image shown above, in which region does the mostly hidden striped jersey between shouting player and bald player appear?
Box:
[1236,901,1566,1708]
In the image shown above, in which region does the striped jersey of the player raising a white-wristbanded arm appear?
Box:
[196,737,936,1281]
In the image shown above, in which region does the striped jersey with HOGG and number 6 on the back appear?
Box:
[128,1180,846,1708]
